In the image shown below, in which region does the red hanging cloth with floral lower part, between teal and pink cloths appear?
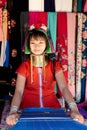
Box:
[57,12,68,81]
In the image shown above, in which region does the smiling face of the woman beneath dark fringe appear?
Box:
[30,37,46,55]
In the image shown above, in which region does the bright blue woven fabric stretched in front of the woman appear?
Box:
[10,108,87,130]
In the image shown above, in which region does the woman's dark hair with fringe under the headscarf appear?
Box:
[27,29,48,50]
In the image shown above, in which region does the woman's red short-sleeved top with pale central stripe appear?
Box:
[16,60,61,109]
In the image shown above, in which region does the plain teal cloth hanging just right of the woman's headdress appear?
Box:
[48,12,57,52]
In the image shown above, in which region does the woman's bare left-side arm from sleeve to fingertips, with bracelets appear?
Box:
[6,74,26,125]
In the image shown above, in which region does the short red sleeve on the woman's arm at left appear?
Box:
[16,61,29,77]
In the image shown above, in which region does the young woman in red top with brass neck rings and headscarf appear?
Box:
[6,23,84,125]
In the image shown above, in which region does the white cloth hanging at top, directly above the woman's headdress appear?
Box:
[28,0,44,11]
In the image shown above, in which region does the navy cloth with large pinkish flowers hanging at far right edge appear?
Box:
[81,13,87,102]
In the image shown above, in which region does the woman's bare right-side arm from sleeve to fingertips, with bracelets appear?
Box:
[55,70,84,123]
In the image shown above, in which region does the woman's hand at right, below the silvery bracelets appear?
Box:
[70,111,84,123]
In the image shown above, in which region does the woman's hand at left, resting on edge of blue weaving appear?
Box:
[6,113,20,126]
